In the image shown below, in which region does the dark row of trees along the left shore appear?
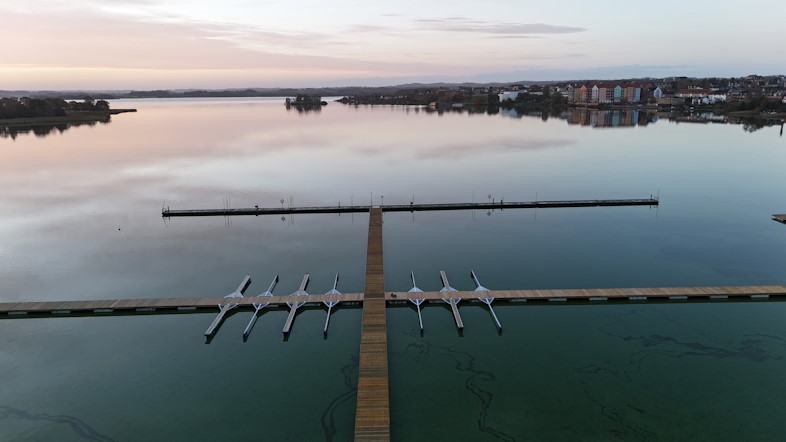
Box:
[0,97,109,120]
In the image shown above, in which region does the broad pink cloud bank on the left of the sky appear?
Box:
[0,10,416,75]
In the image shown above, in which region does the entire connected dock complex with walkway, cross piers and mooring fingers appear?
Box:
[9,198,786,440]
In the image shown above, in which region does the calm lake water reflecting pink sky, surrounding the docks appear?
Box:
[0,100,786,441]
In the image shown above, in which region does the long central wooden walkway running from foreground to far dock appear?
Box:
[355,208,390,441]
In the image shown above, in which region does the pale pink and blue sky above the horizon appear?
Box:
[0,0,786,90]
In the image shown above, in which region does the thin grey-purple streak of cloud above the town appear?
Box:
[415,17,586,36]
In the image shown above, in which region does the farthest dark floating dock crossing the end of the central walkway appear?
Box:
[161,198,658,218]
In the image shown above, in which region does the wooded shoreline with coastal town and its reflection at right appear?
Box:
[330,75,786,134]
